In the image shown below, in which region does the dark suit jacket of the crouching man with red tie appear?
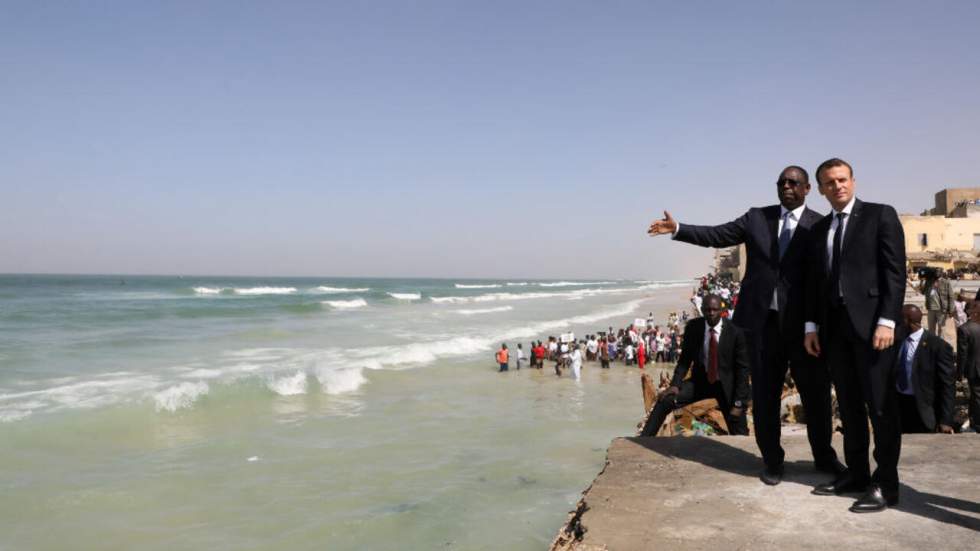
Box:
[670,318,750,404]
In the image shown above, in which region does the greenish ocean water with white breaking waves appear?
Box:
[0,275,691,549]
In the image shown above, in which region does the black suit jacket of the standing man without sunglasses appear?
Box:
[800,199,906,411]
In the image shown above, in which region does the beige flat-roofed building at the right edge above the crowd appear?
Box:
[899,187,980,269]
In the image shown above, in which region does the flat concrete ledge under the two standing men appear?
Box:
[553,434,980,551]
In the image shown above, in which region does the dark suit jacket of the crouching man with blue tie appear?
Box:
[893,326,956,430]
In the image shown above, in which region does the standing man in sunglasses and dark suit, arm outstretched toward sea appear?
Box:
[649,166,843,484]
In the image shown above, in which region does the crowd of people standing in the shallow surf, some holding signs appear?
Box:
[495,311,690,379]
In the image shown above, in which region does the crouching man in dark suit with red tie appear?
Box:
[642,295,749,436]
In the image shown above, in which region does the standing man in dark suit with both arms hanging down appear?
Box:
[804,159,905,513]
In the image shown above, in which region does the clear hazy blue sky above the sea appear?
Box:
[0,0,980,279]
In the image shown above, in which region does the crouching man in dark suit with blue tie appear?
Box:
[892,304,956,434]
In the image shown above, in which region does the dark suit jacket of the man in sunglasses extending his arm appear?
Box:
[674,205,820,341]
